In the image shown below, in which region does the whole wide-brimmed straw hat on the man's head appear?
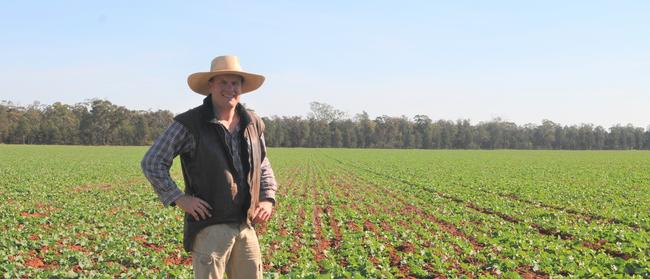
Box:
[187,55,264,96]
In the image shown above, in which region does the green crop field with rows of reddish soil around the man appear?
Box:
[0,145,650,278]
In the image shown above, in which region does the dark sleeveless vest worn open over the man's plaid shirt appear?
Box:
[174,95,266,252]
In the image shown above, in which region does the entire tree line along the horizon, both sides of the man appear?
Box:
[0,99,650,150]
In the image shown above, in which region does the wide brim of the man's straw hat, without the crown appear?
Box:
[187,71,264,96]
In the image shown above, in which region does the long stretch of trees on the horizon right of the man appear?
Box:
[264,102,650,150]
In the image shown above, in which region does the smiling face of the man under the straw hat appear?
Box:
[209,75,242,110]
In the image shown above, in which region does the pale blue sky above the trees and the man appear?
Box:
[0,0,650,128]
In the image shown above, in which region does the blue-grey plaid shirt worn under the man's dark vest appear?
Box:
[140,121,277,206]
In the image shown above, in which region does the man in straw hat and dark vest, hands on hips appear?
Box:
[141,56,277,278]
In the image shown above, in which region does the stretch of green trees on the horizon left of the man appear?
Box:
[0,99,174,145]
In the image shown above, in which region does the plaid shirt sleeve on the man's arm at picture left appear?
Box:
[140,121,194,207]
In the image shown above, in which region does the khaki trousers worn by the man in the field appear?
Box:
[192,222,262,279]
